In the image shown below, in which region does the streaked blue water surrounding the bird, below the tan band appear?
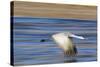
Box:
[13,17,97,65]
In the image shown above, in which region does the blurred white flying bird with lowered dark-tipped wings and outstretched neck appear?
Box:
[52,33,84,56]
